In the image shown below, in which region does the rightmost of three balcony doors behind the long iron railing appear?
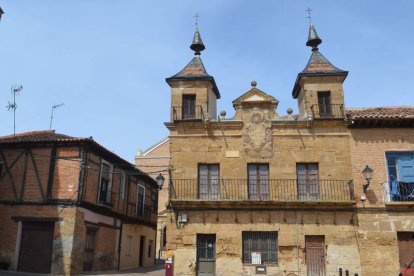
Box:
[296,164,319,200]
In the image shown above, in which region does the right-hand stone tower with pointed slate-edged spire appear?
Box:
[292,23,348,118]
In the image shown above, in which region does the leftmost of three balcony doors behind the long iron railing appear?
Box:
[198,164,220,199]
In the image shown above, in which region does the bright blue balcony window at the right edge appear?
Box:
[385,152,414,201]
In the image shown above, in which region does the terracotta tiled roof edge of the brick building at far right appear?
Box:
[345,106,414,120]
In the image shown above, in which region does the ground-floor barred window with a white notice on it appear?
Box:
[242,232,278,264]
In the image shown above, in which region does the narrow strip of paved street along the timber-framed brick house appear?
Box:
[0,264,165,276]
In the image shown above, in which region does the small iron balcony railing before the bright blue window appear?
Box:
[382,180,414,202]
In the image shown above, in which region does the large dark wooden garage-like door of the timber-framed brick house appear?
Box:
[18,222,55,273]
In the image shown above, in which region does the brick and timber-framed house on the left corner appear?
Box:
[0,131,158,275]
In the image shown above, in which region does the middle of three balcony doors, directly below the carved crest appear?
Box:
[247,164,269,200]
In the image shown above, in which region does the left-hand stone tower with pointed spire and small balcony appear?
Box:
[166,27,220,121]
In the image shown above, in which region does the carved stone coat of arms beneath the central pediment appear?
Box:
[242,109,273,157]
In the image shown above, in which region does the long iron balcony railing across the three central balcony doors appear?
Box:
[170,179,354,201]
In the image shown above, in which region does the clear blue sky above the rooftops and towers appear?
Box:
[0,0,414,162]
